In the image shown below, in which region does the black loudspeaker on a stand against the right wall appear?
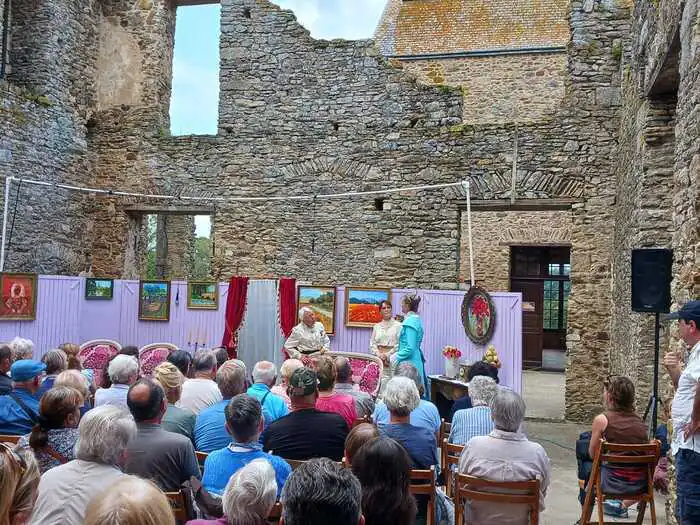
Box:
[632,248,673,313]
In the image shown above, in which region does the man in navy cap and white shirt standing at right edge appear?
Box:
[663,301,700,525]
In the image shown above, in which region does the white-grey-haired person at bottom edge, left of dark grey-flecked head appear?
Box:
[193,459,277,525]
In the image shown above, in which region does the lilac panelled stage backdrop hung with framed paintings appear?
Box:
[0,276,522,392]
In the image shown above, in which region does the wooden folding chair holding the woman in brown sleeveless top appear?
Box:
[579,439,661,525]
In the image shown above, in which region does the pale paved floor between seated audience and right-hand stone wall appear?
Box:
[523,371,666,525]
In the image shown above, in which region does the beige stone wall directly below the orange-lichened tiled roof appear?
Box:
[402,52,567,124]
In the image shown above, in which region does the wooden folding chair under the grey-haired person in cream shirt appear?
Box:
[455,474,540,525]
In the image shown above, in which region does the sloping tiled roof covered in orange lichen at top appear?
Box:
[374,0,569,55]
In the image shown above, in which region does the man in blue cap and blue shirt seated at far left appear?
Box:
[0,359,46,436]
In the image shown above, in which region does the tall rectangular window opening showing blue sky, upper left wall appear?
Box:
[170,4,221,135]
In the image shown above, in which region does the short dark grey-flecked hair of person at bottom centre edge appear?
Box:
[280,458,365,525]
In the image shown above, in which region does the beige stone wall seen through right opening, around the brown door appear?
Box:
[460,209,572,292]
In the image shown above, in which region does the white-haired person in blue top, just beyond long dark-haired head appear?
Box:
[379,376,438,470]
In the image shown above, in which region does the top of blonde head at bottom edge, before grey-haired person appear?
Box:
[85,476,175,525]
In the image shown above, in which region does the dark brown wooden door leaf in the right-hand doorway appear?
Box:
[510,279,544,368]
